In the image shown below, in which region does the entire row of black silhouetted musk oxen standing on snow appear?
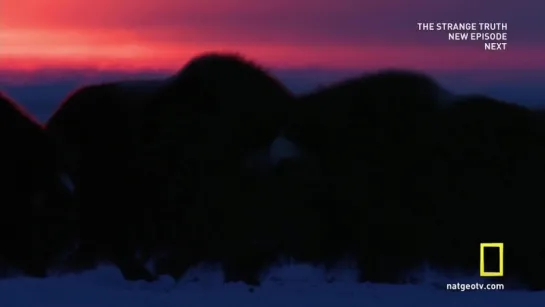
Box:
[0,54,545,290]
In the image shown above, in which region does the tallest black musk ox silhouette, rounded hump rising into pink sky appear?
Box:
[131,53,294,280]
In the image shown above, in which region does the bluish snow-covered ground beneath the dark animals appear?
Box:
[0,265,545,307]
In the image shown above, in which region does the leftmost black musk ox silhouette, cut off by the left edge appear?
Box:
[0,93,75,276]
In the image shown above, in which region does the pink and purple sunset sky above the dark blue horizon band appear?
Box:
[0,0,545,118]
